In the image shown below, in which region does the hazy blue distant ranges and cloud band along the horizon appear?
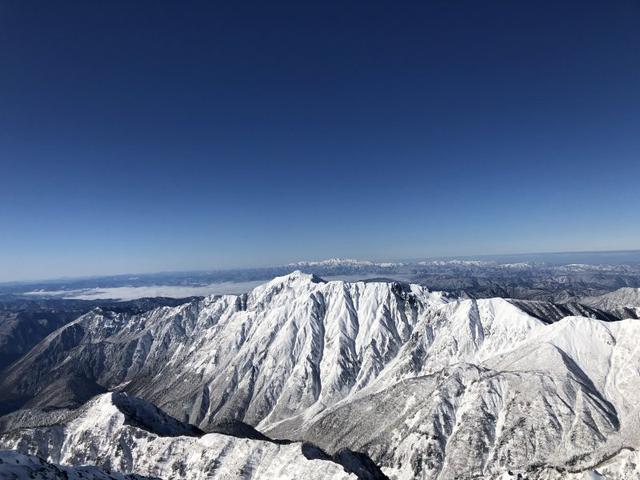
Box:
[0,251,640,302]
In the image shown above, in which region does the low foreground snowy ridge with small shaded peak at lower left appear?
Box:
[0,393,356,480]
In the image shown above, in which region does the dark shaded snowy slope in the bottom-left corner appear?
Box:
[0,450,152,480]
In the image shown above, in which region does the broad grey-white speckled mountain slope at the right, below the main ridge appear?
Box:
[298,317,640,479]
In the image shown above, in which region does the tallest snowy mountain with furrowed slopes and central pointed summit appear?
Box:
[0,272,445,430]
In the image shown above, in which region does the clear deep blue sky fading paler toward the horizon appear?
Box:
[0,0,640,280]
